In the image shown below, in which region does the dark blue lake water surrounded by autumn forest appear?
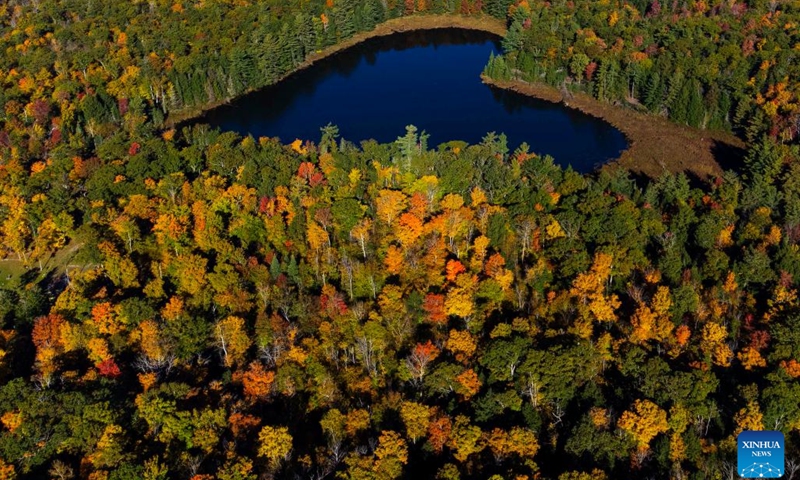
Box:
[204,30,627,172]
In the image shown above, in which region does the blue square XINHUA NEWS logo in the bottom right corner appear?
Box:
[736,430,784,478]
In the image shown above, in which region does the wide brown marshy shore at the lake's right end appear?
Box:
[481,75,745,179]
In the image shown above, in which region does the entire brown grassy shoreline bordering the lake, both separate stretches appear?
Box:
[164,14,745,179]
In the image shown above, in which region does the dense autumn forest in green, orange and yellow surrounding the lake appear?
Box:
[0,0,800,480]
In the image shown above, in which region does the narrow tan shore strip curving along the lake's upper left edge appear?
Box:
[164,15,506,128]
